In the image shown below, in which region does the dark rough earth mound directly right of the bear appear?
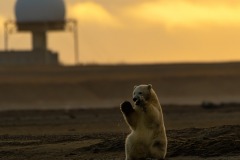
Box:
[168,125,240,157]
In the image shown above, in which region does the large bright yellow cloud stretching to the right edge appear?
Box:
[125,0,240,28]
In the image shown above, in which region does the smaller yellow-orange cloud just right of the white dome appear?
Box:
[69,2,121,27]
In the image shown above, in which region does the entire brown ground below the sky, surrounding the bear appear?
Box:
[0,63,240,160]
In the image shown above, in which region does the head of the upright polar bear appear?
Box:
[133,84,152,106]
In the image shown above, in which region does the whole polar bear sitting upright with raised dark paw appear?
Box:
[120,84,167,160]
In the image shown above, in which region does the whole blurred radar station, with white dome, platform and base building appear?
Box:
[0,0,78,65]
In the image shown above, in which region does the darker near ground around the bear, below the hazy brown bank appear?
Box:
[0,105,240,160]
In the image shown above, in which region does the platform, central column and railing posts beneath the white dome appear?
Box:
[4,19,79,65]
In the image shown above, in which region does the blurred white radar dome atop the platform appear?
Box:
[15,0,65,22]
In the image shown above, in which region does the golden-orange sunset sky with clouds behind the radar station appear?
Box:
[0,0,240,64]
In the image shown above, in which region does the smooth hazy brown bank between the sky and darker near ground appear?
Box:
[0,63,240,110]
